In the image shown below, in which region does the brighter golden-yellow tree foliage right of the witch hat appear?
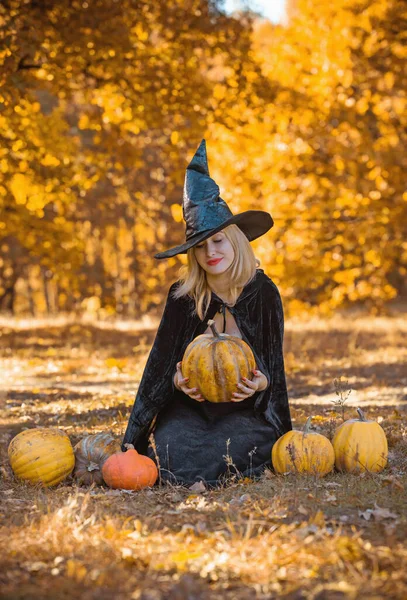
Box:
[209,0,407,311]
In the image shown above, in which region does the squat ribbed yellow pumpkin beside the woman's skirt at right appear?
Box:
[271,417,335,477]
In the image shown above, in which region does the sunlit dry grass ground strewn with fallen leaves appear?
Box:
[0,315,407,600]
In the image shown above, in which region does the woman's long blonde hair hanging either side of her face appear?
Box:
[173,225,260,321]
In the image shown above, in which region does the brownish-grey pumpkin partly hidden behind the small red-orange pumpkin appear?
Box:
[73,433,120,485]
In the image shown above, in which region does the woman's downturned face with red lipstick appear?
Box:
[194,231,235,275]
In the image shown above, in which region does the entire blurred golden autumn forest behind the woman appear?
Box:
[0,0,407,318]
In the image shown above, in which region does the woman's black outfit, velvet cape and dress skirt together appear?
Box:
[122,269,291,485]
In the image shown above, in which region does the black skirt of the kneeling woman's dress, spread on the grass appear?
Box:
[148,394,279,486]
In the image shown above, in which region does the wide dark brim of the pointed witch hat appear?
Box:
[154,210,274,259]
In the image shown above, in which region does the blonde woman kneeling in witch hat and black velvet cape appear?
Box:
[123,140,291,486]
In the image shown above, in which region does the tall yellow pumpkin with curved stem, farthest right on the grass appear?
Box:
[332,408,388,473]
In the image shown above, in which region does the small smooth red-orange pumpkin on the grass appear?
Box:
[102,444,158,490]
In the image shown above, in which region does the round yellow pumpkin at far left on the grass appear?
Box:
[8,427,75,487]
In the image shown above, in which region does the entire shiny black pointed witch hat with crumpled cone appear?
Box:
[155,140,274,258]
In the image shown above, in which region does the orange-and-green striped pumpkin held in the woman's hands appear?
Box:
[182,320,256,402]
